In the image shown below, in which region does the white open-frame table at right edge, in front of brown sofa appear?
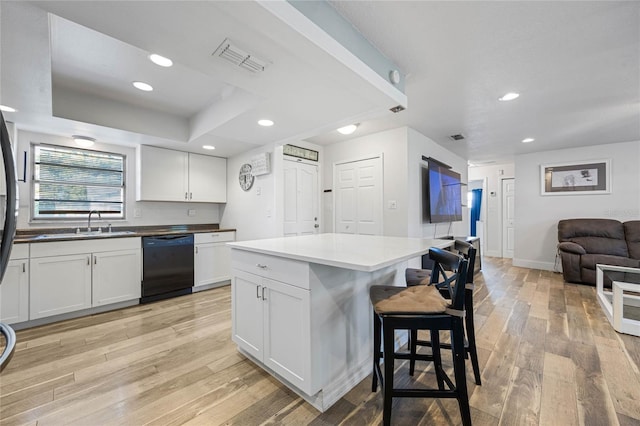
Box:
[596,264,640,336]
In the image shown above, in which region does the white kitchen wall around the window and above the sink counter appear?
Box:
[16,130,221,229]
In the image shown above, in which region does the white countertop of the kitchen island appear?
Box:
[227,234,453,272]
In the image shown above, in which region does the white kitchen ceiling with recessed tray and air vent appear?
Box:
[0,1,406,157]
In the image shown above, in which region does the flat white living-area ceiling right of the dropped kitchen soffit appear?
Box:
[314,1,640,162]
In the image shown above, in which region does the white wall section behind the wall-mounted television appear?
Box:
[406,128,469,238]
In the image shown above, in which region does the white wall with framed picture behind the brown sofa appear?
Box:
[513,141,640,270]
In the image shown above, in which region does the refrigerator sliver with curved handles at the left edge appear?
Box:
[0,112,18,372]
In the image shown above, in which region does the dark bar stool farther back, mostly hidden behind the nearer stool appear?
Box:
[405,240,482,385]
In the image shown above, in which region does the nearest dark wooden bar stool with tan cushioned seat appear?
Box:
[369,248,471,426]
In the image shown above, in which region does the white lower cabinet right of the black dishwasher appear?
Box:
[194,232,236,287]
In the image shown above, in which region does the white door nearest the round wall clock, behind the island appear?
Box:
[284,160,320,236]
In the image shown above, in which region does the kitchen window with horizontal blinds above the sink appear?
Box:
[33,145,125,219]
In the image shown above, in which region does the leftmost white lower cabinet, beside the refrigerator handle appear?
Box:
[0,244,29,324]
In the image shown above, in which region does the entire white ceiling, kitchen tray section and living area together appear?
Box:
[0,0,640,163]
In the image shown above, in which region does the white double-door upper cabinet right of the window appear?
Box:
[136,145,227,203]
